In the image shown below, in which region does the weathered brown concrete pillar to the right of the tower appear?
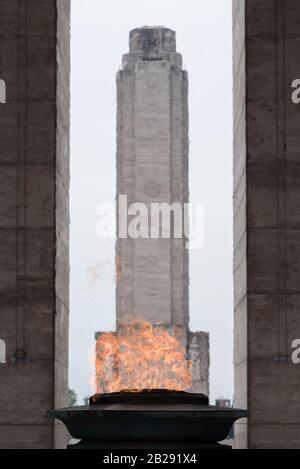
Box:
[233,0,300,448]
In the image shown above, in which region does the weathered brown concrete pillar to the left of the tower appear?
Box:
[0,0,70,448]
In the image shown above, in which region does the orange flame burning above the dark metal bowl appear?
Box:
[95,320,192,394]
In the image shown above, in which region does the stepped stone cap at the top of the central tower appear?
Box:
[123,26,182,68]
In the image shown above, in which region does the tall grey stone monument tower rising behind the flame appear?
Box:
[96,26,209,394]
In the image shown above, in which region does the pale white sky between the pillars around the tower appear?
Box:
[70,0,233,403]
